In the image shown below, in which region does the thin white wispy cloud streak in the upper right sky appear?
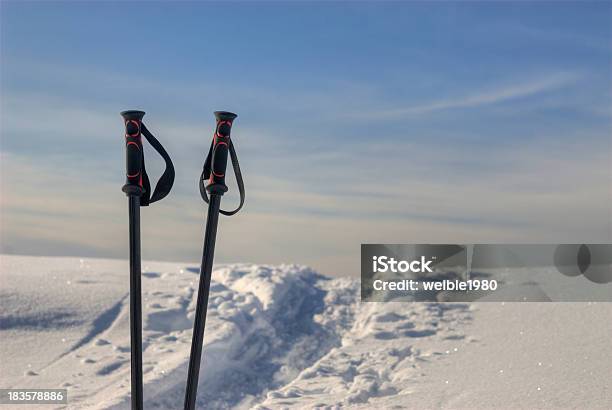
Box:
[360,72,579,119]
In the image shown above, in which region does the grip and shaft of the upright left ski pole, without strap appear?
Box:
[121,111,145,410]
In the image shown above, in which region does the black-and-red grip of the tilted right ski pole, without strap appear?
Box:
[207,111,237,193]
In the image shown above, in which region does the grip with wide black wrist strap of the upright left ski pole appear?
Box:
[121,111,174,206]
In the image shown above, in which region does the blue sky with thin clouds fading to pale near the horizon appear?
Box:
[0,1,612,275]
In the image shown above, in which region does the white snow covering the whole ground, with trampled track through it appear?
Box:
[0,255,612,409]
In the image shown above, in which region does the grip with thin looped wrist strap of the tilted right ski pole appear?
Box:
[199,111,245,216]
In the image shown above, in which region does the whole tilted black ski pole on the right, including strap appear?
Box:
[184,111,245,410]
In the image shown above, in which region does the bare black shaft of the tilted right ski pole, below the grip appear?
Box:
[185,193,221,410]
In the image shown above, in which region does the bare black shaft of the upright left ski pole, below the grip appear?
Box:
[129,195,143,410]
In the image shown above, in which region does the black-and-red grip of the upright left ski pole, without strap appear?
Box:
[121,110,145,196]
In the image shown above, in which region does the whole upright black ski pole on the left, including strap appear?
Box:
[121,111,174,410]
